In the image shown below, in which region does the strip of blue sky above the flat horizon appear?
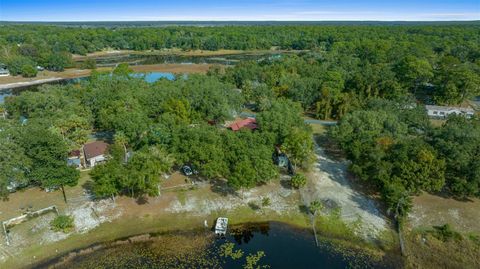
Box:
[0,0,480,21]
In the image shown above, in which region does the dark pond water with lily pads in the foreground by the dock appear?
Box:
[38,222,395,269]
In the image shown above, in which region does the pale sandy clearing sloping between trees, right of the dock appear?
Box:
[301,144,388,239]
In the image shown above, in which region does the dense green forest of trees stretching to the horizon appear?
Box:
[0,24,480,218]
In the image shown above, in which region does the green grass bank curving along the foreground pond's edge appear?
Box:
[8,207,308,268]
